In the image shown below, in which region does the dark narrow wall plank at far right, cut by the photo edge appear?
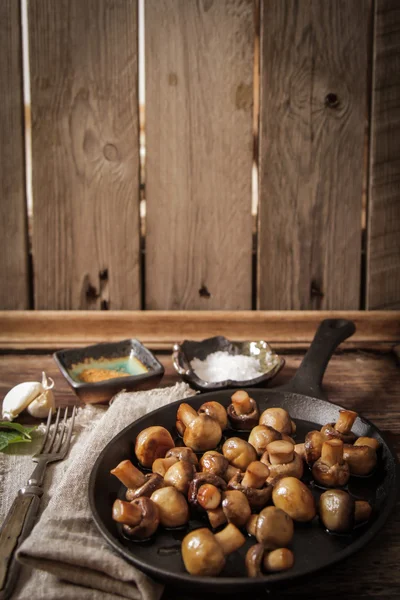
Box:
[366,0,400,309]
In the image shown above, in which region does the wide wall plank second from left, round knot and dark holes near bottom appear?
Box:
[28,0,140,309]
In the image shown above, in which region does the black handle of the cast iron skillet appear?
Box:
[279,319,356,399]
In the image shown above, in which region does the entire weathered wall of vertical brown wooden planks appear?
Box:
[0,0,400,310]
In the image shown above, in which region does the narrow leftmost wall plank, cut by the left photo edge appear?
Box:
[0,0,29,309]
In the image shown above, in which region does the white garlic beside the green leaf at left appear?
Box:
[3,372,55,421]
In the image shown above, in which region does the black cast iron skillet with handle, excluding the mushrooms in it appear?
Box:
[89,319,399,593]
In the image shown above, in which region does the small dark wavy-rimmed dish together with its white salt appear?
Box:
[172,335,285,391]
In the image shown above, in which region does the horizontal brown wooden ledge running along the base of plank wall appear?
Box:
[0,311,400,350]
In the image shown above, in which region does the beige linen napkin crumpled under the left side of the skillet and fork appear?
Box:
[0,383,195,600]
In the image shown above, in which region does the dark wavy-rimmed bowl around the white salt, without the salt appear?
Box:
[172,335,285,391]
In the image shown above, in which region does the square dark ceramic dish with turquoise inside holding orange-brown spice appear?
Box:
[53,339,164,404]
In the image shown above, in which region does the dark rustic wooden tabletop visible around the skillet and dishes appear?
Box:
[0,346,400,600]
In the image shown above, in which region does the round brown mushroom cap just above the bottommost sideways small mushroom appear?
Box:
[256,506,294,550]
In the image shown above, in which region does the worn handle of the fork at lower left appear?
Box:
[0,492,40,599]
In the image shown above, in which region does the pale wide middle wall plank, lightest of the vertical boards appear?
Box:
[145,0,254,309]
